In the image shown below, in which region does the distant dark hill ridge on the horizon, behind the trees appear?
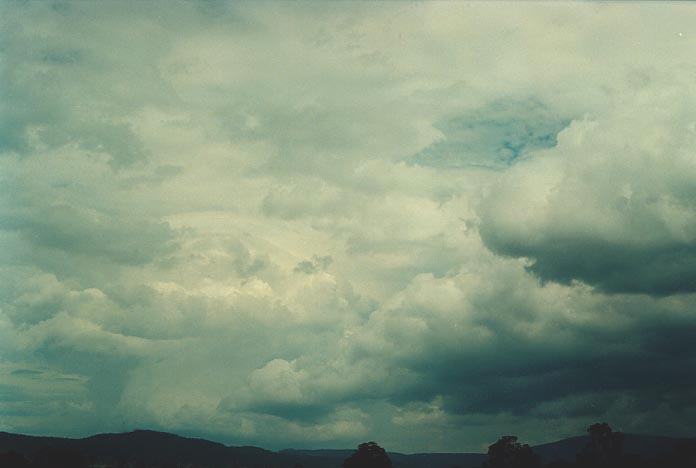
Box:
[0,430,682,468]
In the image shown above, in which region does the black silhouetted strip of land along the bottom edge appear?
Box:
[0,430,696,468]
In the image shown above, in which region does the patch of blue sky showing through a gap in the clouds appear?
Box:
[407,99,571,169]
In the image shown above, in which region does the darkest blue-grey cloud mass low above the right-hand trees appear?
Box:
[330,266,696,438]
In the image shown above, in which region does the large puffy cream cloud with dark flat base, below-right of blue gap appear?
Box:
[481,78,696,295]
